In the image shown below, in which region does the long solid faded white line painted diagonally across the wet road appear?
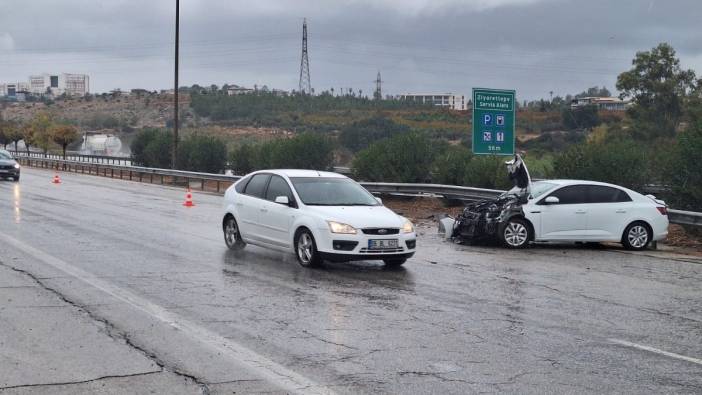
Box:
[0,232,334,394]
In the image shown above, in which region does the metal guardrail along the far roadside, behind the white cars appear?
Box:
[17,154,702,226]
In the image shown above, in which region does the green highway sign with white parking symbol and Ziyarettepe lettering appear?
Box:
[473,88,516,155]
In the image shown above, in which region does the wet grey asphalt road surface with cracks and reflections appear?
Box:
[0,168,702,394]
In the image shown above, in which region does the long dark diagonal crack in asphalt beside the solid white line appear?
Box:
[0,261,210,395]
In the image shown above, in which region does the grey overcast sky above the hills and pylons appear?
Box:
[0,0,702,99]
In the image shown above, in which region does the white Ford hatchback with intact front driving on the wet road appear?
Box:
[222,170,416,266]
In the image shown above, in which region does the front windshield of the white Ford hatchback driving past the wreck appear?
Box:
[290,177,379,206]
